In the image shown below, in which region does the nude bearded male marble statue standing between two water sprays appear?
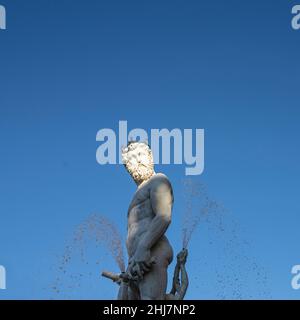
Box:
[119,142,173,300]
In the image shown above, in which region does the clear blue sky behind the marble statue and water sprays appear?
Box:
[0,0,300,299]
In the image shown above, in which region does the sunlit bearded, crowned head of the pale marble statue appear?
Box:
[122,141,155,185]
